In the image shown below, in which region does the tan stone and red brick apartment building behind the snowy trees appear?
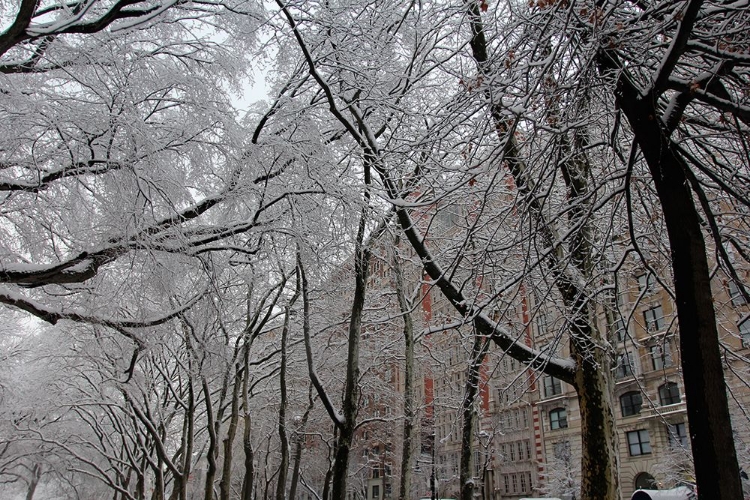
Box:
[346,224,750,500]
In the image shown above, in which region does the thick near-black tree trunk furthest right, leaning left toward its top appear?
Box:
[616,77,742,500]
